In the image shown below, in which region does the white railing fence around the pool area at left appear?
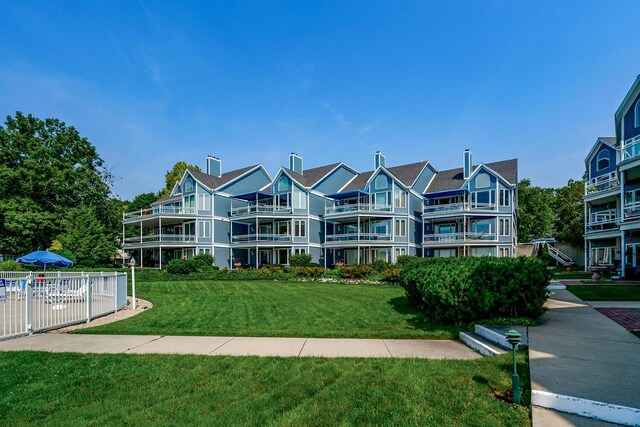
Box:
[0,272,127,340]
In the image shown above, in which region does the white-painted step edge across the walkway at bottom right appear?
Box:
[531,390,640,426]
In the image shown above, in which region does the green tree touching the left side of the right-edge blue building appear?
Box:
[554,179,584,247]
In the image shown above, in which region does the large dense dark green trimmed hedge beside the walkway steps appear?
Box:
[400,257,551,324]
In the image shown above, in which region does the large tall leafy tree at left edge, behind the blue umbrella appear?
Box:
[0,112,112,253]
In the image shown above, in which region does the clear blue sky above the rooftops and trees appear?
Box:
[0,0,640,198]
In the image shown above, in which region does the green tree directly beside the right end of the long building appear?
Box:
[518,179,556,242]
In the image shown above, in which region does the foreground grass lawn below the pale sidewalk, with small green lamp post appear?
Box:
[0,352,530,426]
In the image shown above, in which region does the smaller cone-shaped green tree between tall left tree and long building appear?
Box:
[59,206,116,264]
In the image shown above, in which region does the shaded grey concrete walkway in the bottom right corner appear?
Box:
[529,290,640,426]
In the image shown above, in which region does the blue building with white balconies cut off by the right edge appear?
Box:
[584,76,640,277]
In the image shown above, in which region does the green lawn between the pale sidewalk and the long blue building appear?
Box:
[76,281,463,338]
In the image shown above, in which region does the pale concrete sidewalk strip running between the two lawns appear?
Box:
[0,334,481,359]
